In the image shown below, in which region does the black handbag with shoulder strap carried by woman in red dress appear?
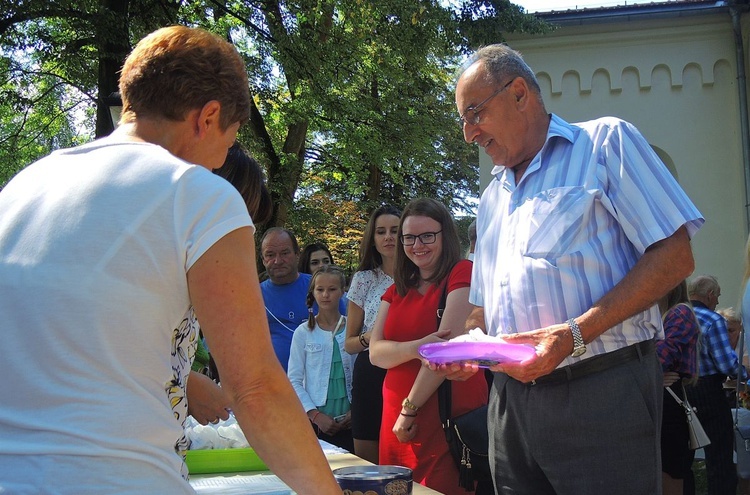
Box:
[437,272,492,492]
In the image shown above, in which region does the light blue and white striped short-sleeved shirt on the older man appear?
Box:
[469,115,703,366]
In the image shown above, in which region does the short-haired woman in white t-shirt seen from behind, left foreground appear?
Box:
[0,26,340,495]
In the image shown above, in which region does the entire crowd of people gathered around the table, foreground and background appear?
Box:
[0,26,750,495]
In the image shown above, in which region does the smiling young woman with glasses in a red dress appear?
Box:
[370,199,487,495]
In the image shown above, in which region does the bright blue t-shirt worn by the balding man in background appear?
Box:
[260,273,312,371]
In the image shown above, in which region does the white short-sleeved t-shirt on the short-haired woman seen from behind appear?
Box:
[0,137,252,494]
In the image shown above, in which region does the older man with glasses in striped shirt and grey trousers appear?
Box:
[450,45,703,495]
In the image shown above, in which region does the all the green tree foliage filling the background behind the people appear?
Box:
[0,0,546,263]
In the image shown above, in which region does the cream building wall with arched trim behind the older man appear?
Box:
[494,8,750,306]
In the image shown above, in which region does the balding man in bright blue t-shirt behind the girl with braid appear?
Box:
[260,227,312,370]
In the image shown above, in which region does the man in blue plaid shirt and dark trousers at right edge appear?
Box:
[685,275,747,494]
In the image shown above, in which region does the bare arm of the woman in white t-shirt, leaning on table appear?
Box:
[188,227,341,495]
